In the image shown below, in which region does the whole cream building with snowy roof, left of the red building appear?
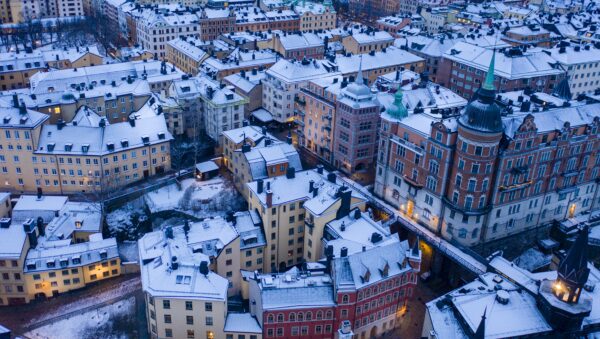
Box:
[138,223,230,339]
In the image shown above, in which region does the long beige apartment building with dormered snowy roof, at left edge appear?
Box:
[0,106,173,194]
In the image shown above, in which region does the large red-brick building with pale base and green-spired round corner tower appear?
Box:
[375,53,600,250]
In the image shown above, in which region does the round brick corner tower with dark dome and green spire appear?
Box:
[444,51,503,246]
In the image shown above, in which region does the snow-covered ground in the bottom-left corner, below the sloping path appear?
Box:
[25,297,136,339]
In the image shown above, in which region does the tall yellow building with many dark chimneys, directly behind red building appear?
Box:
[247,167,367,272]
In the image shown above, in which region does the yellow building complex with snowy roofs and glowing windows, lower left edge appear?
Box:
[0,195,121,305]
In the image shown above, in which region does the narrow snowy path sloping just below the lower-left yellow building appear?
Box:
[29,277,141,328]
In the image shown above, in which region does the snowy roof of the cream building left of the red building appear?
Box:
[138,218,231,301]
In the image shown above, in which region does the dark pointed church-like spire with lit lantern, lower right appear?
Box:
[538,227,592,332]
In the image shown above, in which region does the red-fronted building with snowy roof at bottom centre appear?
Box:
[248,241,421,338]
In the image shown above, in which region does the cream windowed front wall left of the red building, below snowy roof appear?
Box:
[145,292,227,339]
